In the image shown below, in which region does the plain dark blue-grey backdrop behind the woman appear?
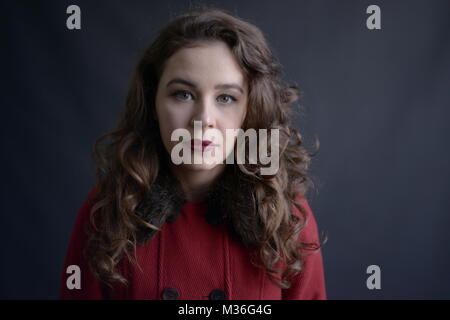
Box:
[0,0,450,299]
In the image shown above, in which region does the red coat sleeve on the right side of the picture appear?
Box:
[282,196,327,300]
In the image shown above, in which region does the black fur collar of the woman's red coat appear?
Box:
[136,164,260,245]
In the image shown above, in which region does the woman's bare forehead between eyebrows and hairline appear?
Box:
[161,42,246,87]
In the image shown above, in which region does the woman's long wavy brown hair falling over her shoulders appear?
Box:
[87,8,321,288]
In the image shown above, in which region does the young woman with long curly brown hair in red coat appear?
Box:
[60,9,326,300]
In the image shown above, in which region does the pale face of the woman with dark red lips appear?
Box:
[156,41,248,170]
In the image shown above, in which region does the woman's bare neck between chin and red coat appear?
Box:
[171,164,225,202]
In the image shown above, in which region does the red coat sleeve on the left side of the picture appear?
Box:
[59,187,104,300]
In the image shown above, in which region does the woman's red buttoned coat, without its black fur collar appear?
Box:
[60,188,326,300]
